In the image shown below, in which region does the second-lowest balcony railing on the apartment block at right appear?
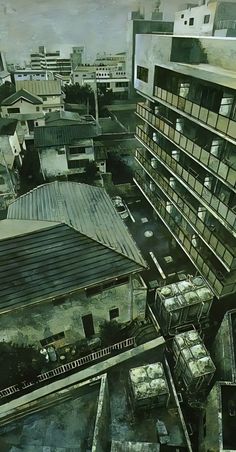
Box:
[136,150,236,271]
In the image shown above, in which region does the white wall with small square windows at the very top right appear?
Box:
[174,1,217,36]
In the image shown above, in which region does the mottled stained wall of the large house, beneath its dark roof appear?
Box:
[1,276,146,345]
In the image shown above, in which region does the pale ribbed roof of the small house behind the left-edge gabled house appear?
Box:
[16,80,61,96]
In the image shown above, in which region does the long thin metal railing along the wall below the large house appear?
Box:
[0,337,136,399]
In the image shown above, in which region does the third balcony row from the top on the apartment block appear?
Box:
[136,126,236,236]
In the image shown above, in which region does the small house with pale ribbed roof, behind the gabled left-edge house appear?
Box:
[16,80,64,112]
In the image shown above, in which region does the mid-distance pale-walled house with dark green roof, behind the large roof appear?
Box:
[34,115,101,180]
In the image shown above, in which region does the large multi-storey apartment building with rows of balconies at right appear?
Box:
[135,34,236,298]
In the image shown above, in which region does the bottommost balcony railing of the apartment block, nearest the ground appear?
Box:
[134,173,224,298]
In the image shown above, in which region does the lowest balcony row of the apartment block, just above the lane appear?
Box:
[134,172,236,298]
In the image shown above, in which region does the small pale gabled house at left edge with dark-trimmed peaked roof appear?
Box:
[1,88,43,117]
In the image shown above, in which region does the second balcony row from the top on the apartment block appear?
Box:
[137,103,236,189]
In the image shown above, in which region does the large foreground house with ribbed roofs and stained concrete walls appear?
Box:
[0,182,146,345]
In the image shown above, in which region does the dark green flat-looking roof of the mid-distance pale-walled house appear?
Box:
[34,121,101,148]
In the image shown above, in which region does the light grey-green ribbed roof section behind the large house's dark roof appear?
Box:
[8,181,147,267]
